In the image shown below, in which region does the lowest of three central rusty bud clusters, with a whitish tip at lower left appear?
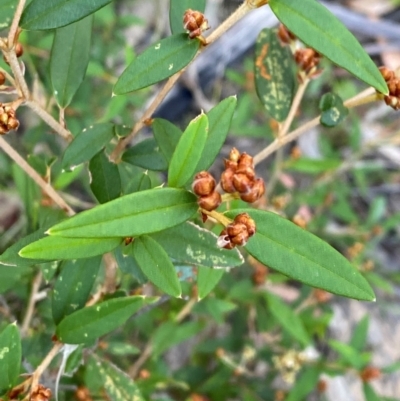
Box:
[217,213,256,249]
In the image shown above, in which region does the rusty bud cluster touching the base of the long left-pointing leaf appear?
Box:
[192,171,222,212]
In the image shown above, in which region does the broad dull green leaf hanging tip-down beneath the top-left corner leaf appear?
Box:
[50,15,93,108]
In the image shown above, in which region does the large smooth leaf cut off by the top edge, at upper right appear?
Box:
[269,0,388,94]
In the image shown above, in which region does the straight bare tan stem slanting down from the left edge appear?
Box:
[0,136,75,216]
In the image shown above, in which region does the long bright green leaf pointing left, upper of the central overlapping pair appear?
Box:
[48,188,198,238]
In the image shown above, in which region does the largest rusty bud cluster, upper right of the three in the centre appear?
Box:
[221,148,265,203]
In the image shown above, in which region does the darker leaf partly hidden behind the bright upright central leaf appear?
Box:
[195,96,237,171]
